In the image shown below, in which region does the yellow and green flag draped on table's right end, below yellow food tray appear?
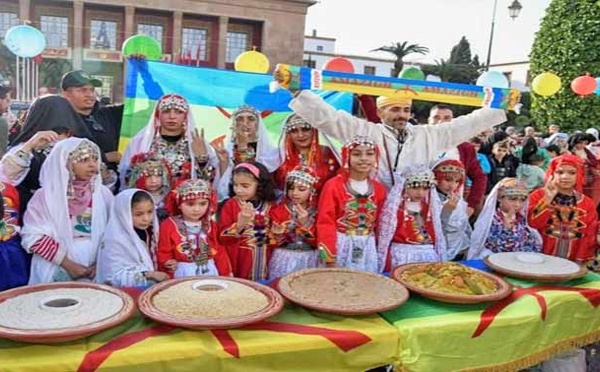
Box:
[381,267,600,372]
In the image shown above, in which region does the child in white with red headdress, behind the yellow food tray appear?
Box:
[433,159,471,260]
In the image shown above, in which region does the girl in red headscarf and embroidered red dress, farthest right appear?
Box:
[528,154,598,263]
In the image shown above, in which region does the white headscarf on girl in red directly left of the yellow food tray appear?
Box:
[377,164,447,271]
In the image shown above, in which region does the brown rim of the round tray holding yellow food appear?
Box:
[390,263,512,304]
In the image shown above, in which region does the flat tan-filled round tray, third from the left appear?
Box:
[279,268,408,316]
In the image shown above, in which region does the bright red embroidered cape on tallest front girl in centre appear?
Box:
[317,175,386,262]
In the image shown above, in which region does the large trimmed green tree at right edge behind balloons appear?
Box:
[530,0,600,131]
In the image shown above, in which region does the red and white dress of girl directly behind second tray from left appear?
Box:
[157,216,231,278]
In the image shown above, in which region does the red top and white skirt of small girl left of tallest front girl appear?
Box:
[269,201,318,279]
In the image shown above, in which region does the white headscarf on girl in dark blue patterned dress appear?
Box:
[467,177,542,260]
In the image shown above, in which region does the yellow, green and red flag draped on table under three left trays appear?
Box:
[0,291,398,372]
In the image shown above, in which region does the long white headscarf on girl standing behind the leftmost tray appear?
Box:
[21,137,113,284]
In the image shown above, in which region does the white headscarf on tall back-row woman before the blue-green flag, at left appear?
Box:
[119,94,219,189]
